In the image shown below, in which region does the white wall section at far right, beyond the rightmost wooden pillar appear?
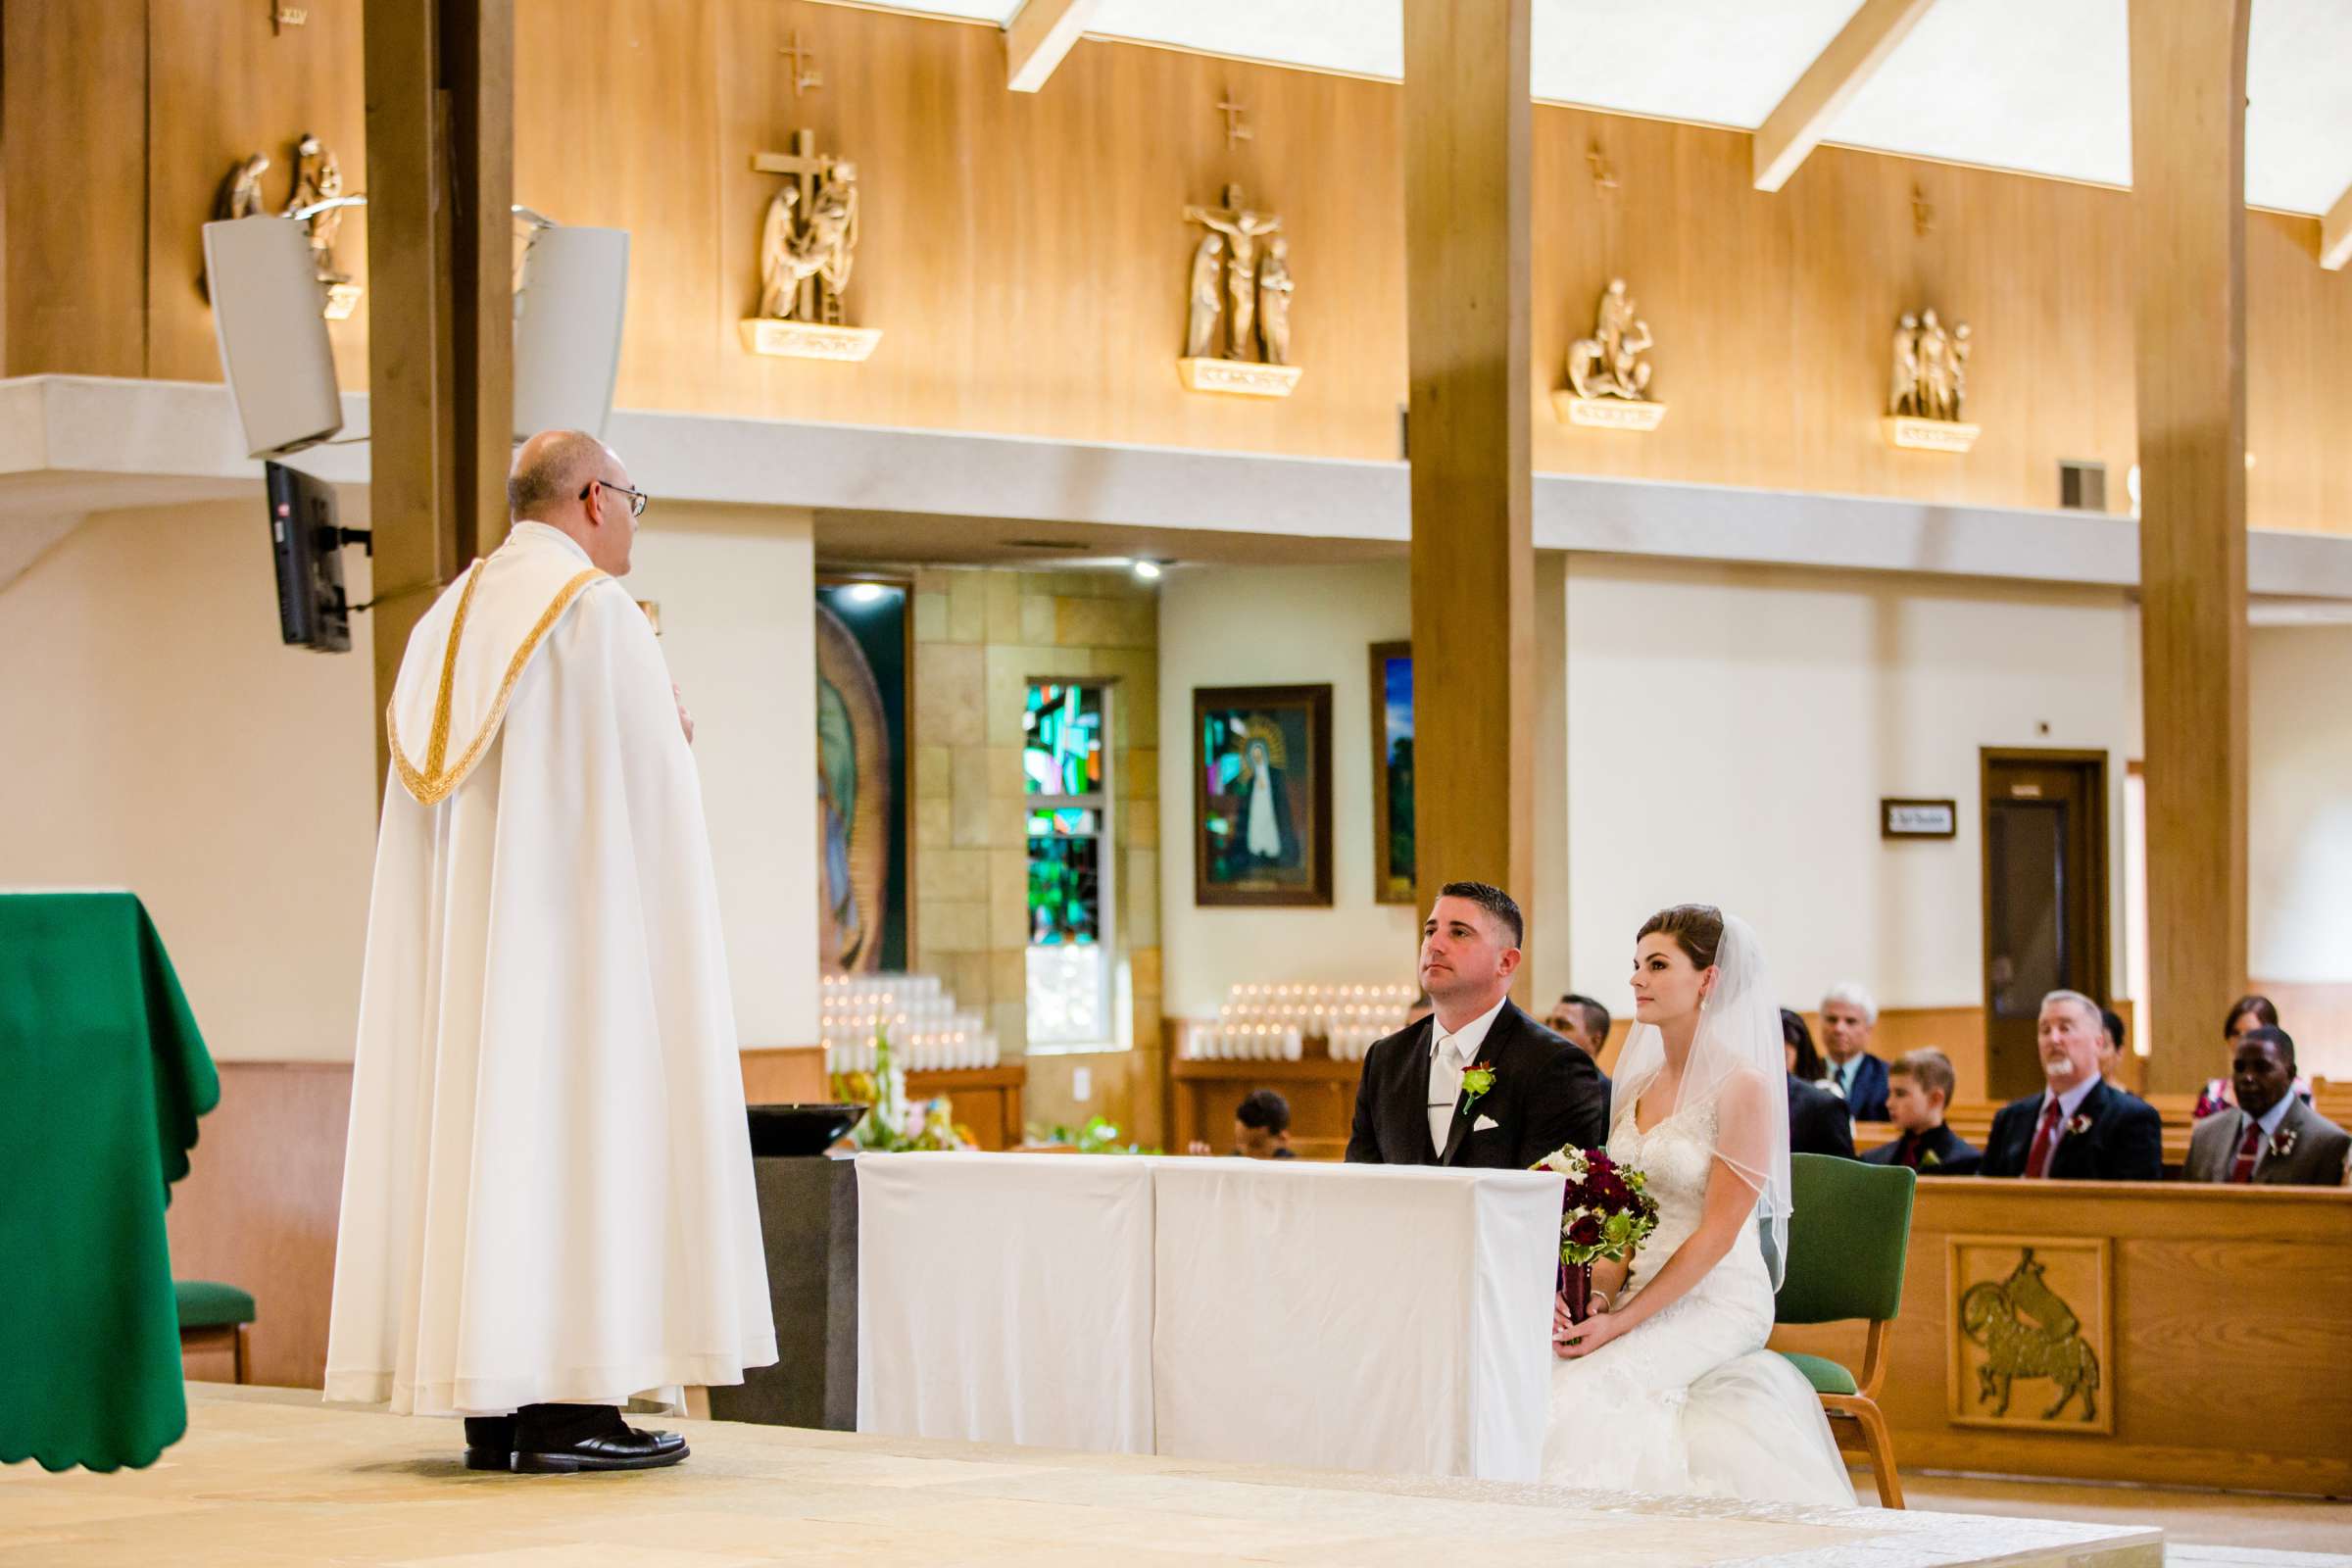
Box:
[2246,625,2352,980]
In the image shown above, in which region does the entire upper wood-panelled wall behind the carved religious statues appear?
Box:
[5,0,2352,531]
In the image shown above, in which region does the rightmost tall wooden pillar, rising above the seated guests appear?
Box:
[2131,0,2251,1093]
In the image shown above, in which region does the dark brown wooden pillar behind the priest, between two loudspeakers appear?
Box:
[365,0,515,778]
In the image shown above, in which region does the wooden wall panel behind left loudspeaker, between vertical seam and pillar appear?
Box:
[142,0,369,393]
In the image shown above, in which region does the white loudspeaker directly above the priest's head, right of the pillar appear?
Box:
[515,223,628,442]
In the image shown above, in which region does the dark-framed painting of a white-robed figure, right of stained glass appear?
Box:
[1193,686,1331,907]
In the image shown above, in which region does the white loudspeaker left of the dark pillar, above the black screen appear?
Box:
[205,219,343,459]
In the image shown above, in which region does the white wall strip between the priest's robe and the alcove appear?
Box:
[628,506,818,1049]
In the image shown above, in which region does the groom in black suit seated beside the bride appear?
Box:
[1348,882,1609,1171]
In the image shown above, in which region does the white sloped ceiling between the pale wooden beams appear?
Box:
[921,0,2352,214]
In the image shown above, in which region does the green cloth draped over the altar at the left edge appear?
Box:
[0,894,221,1469]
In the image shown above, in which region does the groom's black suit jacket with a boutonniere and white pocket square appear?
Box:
[1348,1002,1609,1171]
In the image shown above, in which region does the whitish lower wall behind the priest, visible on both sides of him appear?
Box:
[0,491,816,1060]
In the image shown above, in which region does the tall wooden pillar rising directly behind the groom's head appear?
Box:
[1404,0,1557,950]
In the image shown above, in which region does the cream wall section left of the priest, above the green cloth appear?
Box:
[0,510,376,1060]
